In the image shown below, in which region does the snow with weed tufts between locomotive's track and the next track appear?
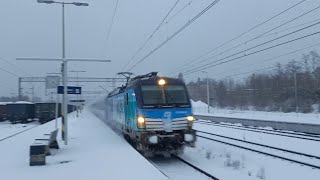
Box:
[181,138,320,180]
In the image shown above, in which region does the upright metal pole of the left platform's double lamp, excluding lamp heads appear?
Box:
[62,3,68,145]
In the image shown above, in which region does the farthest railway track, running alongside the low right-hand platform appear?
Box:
[196,120,320,142]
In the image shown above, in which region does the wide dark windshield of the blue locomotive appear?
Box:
[141,85,189,105]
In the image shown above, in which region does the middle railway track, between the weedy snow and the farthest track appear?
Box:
[197,131,320,169]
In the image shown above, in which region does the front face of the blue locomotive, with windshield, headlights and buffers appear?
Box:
[135,76,196,154]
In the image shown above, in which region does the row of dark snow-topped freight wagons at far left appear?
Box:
[0,101,75,124]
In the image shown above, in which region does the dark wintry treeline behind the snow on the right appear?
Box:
[184,51,320,113]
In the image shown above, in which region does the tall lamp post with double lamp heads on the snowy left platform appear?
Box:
[37,0,89,145]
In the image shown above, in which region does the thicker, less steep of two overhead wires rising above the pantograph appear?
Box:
[128,0,220,71]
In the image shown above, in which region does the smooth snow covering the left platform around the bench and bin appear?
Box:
[0,111,167,180]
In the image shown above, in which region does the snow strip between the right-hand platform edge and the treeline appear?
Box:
[191,101,320,124]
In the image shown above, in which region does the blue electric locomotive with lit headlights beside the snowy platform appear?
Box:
[104,72,196,156]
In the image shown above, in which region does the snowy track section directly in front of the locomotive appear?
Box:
[147,156,219,180]
